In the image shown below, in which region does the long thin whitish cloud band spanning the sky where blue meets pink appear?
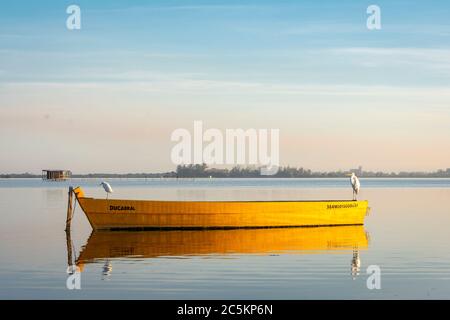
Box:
[0,80,450,98]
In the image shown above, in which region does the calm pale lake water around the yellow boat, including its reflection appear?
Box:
[0,179,450,299]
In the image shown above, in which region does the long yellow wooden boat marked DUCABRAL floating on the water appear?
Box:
[68,187,368,230]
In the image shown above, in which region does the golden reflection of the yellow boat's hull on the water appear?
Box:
[76,226,369,268]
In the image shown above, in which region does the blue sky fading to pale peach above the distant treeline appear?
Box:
[0,0,450,173]
